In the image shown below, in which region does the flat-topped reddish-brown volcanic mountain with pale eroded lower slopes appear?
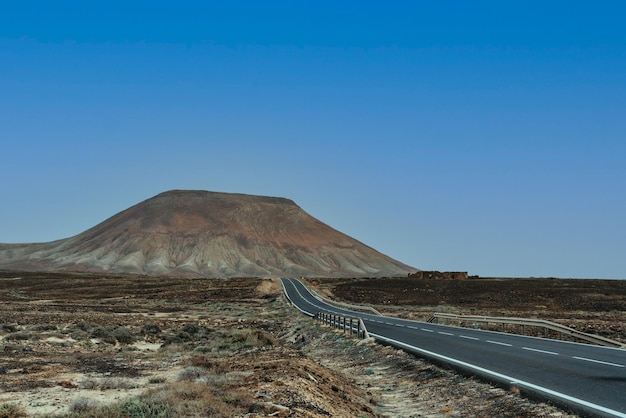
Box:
[0,190,416,277]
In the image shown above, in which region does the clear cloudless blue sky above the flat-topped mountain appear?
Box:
[0,0,626,278]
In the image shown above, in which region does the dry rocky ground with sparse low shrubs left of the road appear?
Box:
[0,272,584,418]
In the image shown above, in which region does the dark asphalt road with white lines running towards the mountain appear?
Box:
[281,279,626,418]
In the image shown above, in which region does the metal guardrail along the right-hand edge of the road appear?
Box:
[426,312,626,348]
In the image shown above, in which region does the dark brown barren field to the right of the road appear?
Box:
[316,278,626,343]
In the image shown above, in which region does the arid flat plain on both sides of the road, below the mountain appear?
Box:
[0,271,626,417]
